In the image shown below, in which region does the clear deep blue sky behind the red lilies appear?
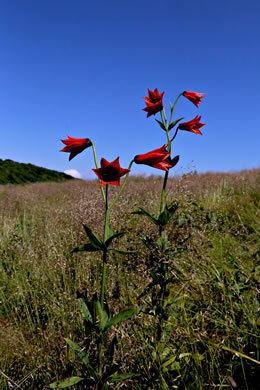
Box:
[0,0,260,178]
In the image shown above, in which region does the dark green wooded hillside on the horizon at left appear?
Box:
[0,159,74,184]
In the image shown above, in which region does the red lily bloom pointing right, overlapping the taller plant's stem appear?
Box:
[134,144,172,171]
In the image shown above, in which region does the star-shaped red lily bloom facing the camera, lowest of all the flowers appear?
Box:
[92,157,130,187]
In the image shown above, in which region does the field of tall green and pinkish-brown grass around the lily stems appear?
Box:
[0,170,260,390]
